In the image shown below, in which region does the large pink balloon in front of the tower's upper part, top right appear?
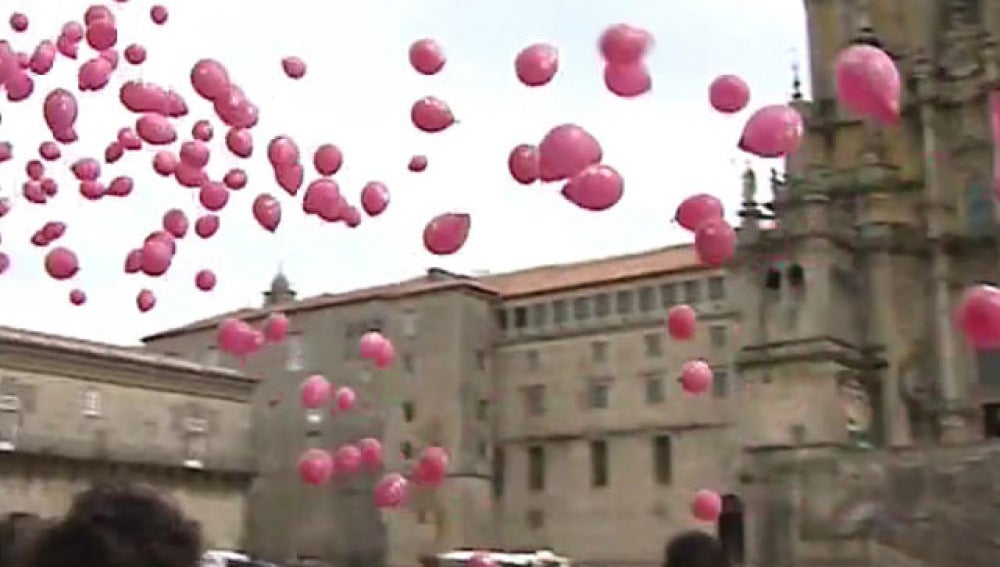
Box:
[836,45,901,125]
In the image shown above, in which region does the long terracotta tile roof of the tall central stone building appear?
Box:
[143,245,705,342]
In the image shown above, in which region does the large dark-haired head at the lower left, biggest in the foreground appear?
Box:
[23,483,202,567]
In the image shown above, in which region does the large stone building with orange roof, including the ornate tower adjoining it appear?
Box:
[146,0,1000,567]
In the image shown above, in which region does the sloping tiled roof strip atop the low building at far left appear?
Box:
[0,326,253,381]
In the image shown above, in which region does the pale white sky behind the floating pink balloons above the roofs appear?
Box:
[0,0,807,344]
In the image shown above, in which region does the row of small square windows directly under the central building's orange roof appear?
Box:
[496,276,726,331]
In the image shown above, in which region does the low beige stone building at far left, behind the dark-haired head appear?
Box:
[0,327,256,549]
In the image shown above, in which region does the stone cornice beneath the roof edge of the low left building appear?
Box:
[0,341,256,402]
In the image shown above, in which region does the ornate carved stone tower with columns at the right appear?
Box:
[734,0,1000,566]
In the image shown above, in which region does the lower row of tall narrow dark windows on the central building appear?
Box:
[493,435,674,497]
